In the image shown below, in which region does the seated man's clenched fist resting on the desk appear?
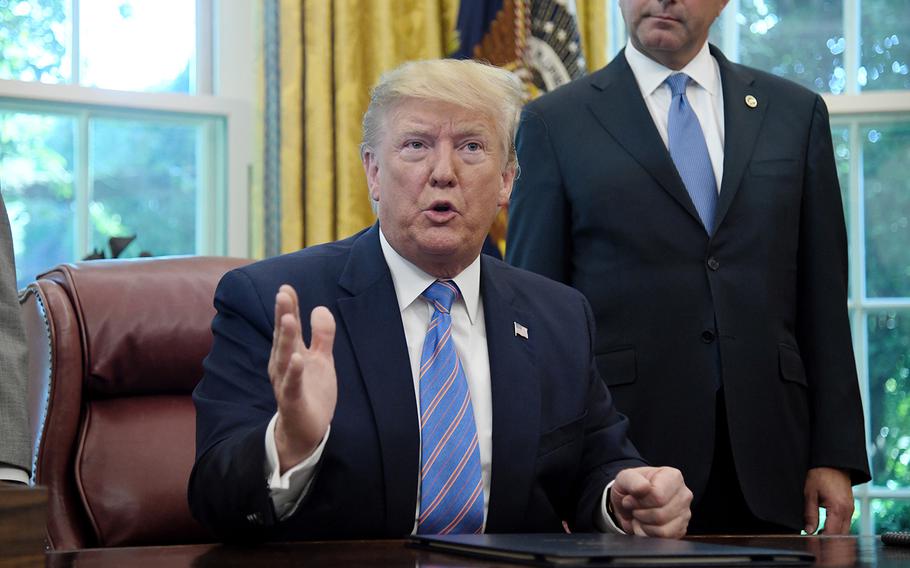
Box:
[610,467,692,538]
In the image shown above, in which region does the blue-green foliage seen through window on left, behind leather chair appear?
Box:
[0,0,202,286]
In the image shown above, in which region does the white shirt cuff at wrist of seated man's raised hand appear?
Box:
[265,413,332,521]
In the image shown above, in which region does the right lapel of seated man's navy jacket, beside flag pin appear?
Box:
[480,255,540,532]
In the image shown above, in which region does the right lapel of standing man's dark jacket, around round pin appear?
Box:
[710,45,770,228]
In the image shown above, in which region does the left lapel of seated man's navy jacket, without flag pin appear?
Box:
[338,224,420,535]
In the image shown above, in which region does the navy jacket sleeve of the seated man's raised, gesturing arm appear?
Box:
[188,271,277,539]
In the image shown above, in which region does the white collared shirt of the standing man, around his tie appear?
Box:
[626,42,724,192]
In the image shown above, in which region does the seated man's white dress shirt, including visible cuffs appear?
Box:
[265,228,622,532]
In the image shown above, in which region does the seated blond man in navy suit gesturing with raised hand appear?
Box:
[189,60,691,540]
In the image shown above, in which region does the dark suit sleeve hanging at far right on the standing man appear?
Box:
[796,97,869,483]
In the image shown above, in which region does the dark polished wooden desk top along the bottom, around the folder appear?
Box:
[47,536,910,568]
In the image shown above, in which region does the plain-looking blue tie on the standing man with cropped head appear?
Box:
[666,73,717,235]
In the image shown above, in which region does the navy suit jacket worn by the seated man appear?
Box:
[189,226,643,540]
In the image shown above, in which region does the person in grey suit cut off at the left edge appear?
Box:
[0,197,31,484]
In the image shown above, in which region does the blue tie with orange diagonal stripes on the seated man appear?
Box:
[417,280,483,534]
